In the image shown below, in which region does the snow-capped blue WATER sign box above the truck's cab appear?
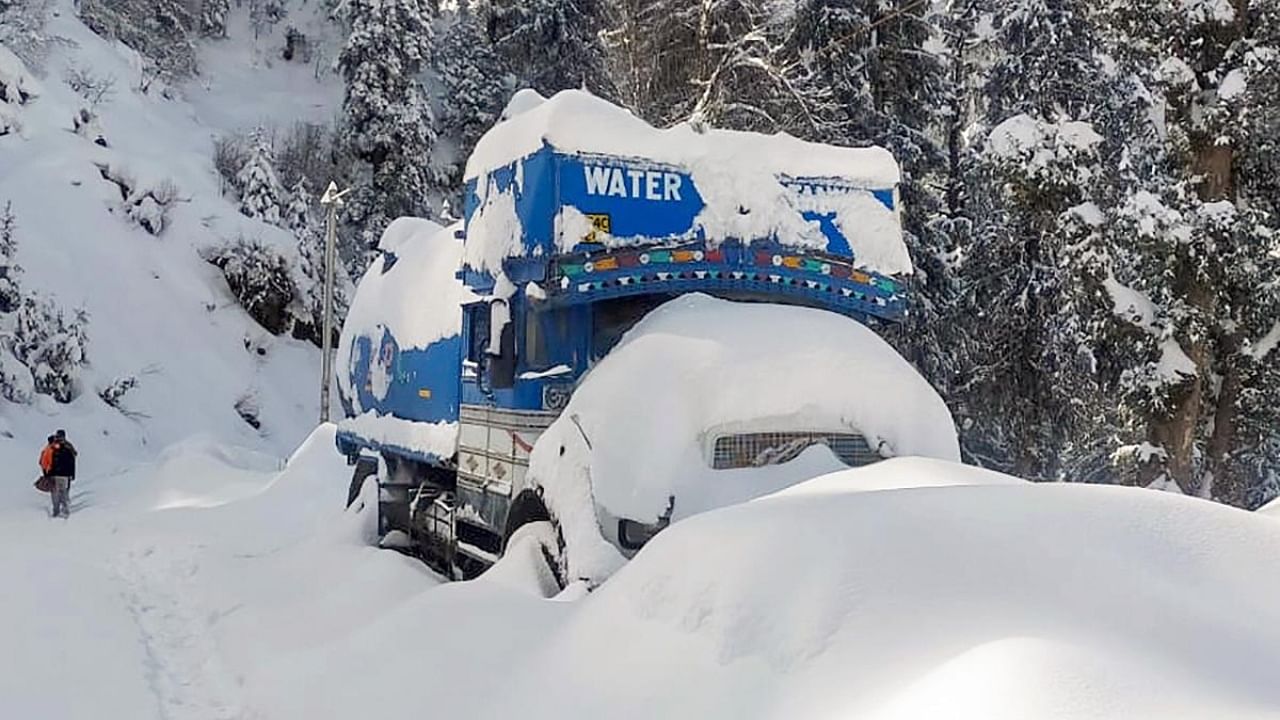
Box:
[465,90,911,275]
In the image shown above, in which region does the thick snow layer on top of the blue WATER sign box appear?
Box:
[466,90,901,188]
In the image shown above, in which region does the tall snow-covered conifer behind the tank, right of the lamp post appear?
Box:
[338,0,435,247]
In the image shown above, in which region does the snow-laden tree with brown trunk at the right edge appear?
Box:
[1080,0,1280,505]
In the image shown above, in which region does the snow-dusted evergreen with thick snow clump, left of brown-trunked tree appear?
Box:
[952,0,1124,479]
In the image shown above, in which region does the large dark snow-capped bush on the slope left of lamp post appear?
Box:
[204,236,297,334]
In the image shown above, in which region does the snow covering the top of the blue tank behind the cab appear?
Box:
[337,218,470,397]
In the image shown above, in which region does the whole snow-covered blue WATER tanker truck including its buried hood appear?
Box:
[338,91,959,584]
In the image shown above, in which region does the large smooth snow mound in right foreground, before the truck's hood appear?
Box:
[496,460,1280,720]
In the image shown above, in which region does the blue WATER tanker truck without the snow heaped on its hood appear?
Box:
[337,91,936,578]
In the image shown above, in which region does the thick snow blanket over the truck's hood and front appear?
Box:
[530,295,960,579]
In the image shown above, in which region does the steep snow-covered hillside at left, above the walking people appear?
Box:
[0,0,340,481]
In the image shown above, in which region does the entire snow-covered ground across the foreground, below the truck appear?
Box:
[0,425,1280,720]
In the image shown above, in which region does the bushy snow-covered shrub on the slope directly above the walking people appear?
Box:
[12,295,88,402]
